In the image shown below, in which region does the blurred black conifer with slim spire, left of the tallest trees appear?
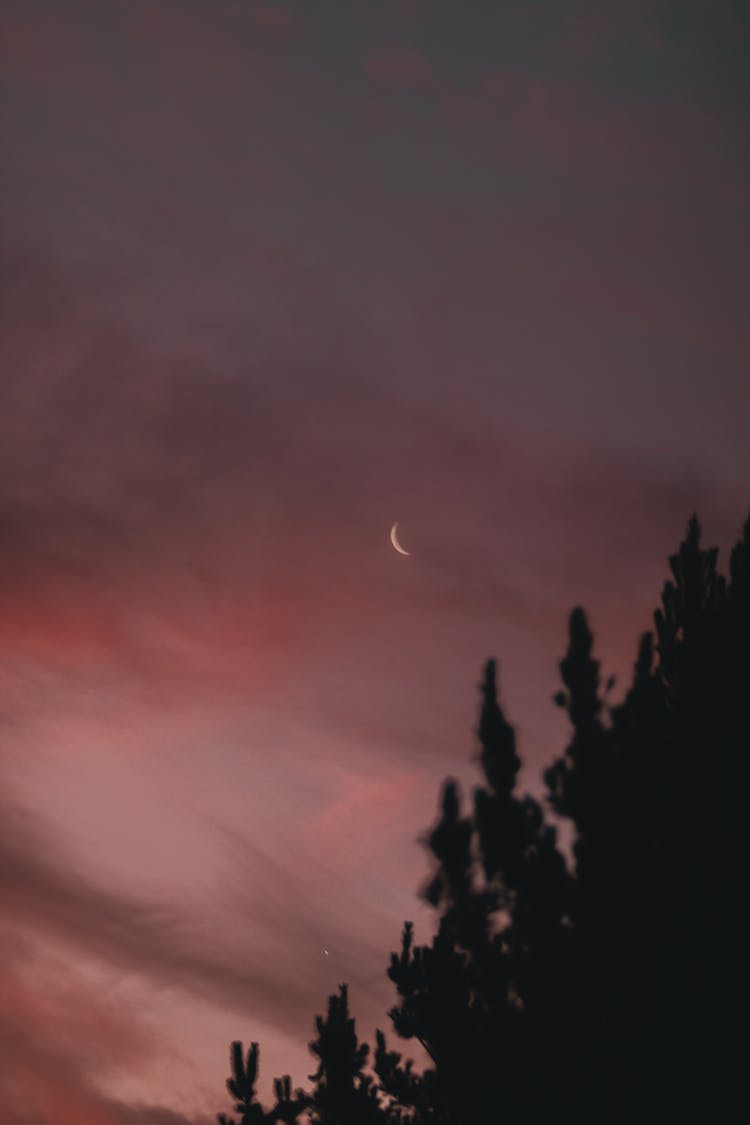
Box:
[389,660,569,1123]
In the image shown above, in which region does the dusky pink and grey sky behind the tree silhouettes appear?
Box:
[0,0,750,1125]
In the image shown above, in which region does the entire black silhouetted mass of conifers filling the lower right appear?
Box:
[218,516,750,1125]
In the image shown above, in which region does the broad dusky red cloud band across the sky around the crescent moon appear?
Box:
[0,232,741,738]
